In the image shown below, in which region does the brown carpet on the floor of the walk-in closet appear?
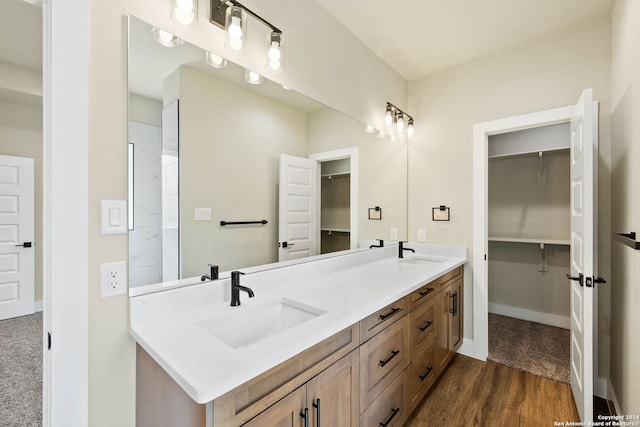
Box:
[489,314,570,384]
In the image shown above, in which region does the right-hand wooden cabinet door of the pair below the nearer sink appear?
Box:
[306,351,360,427]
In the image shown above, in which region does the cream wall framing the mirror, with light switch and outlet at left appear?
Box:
[88,0,407,426]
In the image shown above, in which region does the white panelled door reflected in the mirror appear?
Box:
[278,154,318,261]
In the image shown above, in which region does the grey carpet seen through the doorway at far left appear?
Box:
[0,312,42,427]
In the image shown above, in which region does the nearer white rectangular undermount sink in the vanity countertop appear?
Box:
[198,298,326,348]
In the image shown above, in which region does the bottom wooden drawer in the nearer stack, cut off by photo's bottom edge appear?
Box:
[360,371,410,427]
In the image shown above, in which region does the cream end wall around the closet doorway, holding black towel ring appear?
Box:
[409,18,611,375]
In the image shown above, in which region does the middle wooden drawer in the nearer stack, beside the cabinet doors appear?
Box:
[360,316,408,411]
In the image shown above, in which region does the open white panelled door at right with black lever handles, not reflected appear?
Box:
[570,89,598,422]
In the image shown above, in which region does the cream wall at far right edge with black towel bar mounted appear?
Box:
[609,0,640,414]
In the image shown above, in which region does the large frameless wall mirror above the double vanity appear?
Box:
[128,18,407,287]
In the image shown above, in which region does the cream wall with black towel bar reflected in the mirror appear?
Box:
[178,67,308,277]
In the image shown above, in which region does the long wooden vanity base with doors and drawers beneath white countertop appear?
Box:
[136,267,463,427]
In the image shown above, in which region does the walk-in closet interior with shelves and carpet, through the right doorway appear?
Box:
[488,123,571,382]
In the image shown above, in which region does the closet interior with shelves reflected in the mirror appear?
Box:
[320,159,351,254]
